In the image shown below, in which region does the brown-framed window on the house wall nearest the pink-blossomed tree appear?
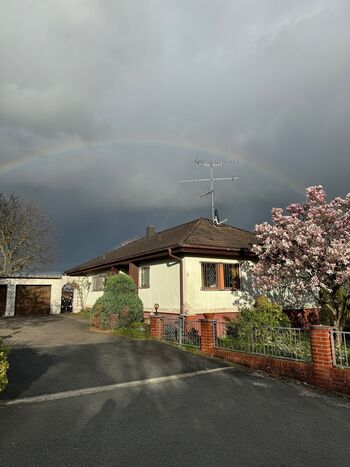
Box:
[202,263,240,290]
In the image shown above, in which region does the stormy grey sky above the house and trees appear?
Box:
[0,0,350,270]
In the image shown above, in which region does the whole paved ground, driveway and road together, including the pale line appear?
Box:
[0,316,350,466]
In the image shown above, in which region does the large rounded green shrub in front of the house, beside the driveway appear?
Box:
[92,274,143,329]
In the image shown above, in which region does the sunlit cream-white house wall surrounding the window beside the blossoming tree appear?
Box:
[183,257,252,315]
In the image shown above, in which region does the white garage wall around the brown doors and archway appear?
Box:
[0,276,85,317]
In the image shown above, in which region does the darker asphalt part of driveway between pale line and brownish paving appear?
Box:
[1,339,230,399]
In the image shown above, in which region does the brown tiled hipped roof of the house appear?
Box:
[66,218,256,274]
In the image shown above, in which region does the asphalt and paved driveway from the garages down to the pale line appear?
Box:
[0,315,225,399]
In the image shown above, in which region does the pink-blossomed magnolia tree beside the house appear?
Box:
[253,186,350,330]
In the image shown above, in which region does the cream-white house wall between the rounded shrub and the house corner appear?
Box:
[139,258,180,313]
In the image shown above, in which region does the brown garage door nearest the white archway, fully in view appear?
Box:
[15,285,51,315]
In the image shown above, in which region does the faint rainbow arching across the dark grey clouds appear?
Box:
[0,139,305,195]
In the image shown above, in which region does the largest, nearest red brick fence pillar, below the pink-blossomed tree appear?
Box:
[311,326,333,389]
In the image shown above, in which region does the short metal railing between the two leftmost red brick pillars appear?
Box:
[162,317,201,347]
